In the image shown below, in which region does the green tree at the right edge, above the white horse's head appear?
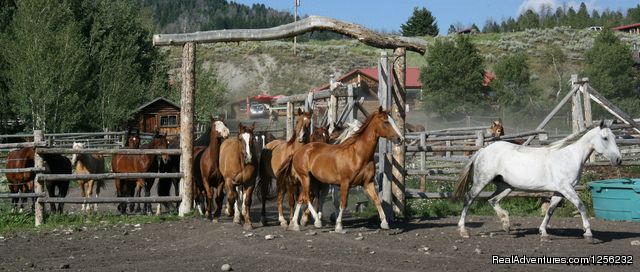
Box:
[584,28,640,113]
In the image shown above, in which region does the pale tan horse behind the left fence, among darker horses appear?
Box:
[71,143,104,212]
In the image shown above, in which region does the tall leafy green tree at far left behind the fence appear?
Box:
[6,0,89,132]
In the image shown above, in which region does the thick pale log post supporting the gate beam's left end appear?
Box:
[178,42,194,216]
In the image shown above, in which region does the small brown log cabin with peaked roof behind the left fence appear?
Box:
[128,97,180,135]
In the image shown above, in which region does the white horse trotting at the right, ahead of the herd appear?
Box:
[455,122,622,241]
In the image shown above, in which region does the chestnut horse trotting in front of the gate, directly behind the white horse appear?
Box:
[277,107,404,232]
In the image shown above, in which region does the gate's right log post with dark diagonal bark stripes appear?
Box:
[390,47,407,215]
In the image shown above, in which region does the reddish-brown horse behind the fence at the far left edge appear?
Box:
[6,147,36,212]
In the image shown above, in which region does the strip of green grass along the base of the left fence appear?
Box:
[0,203,185,236]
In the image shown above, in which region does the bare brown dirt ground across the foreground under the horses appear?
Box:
[0,194,640,271]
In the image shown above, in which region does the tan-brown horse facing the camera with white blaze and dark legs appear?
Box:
[220,123,258,230]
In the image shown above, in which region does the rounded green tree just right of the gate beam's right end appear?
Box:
[420,35,486,118]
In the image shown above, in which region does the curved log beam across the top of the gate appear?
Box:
[153,16,427,54]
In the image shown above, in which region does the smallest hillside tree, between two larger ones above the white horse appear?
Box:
[494,53,541,113]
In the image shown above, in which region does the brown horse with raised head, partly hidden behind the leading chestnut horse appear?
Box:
[257,109,311,227]
